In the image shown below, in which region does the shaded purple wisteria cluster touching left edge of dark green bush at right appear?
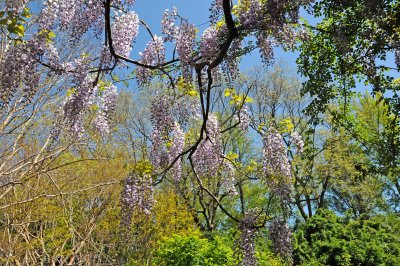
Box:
[268,219,292,260]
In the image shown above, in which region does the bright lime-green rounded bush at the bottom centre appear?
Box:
[155,234,233,266]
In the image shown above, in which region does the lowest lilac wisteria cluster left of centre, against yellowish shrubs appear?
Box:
[121,173,155,226]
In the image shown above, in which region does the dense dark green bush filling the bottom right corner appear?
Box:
[294,210,400,266]
